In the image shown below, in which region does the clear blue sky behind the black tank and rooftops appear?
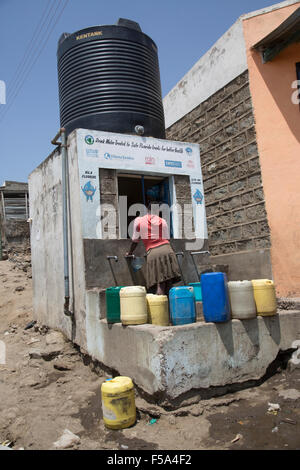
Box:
[0,0,284,185]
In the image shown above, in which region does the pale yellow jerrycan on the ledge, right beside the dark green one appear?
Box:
[120,286,147,325]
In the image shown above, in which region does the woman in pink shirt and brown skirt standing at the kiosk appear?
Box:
[127,202,180,295]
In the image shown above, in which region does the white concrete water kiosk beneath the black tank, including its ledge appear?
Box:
[29,125,300,403]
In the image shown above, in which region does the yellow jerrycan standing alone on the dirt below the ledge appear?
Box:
[101,376,136,429]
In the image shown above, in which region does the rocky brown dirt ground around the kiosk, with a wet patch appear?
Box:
[0,253,300,450]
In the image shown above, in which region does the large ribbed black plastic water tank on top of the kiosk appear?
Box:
[57,19,165,138]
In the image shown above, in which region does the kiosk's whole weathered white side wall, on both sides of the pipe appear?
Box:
[29,133,86,347]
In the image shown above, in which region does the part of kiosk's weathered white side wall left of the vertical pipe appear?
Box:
[28,153,71,337]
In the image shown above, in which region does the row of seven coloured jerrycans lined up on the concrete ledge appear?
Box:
[106,273,277,326]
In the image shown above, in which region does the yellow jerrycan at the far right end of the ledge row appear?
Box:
[252,279,277,317]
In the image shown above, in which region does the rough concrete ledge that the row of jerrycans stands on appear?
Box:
[86,309,300,401]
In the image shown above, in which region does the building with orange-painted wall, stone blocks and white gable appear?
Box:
[164,1,300,297]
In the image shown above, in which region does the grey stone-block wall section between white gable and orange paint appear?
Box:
[167,71,270,255]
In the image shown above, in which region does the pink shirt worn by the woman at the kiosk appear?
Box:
[132,214,170,251]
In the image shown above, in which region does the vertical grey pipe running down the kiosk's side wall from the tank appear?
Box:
[51,127,73,317]
